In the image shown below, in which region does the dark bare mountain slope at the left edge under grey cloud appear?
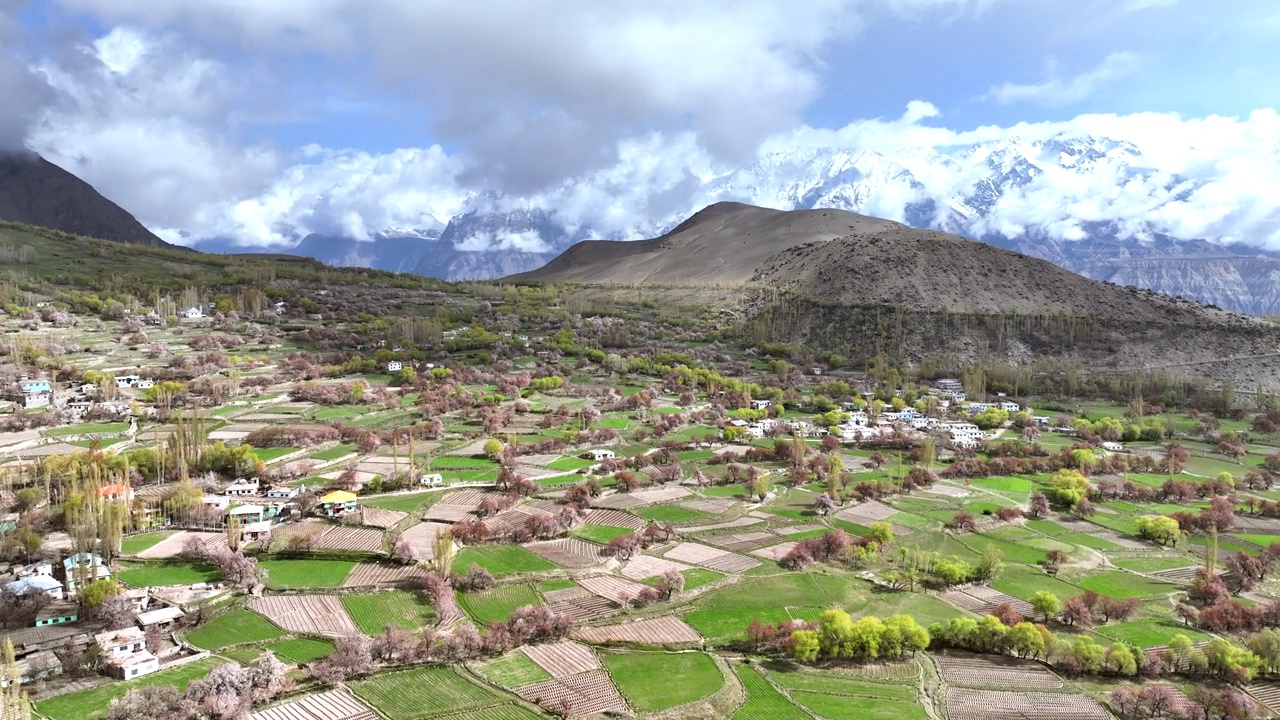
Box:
[0,154,173,247]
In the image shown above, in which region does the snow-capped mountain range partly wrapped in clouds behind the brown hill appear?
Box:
[197,136,1280,315]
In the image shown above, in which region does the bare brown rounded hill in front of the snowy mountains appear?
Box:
[507,202,1226,318]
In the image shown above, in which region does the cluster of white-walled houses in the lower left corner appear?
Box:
[0,552,194,685]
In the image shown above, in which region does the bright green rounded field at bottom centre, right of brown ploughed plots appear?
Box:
[602,652,723,712]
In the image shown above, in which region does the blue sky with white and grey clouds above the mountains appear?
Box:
[0,0,1280,249]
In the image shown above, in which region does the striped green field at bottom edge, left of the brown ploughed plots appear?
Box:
[351,666,503,720]
